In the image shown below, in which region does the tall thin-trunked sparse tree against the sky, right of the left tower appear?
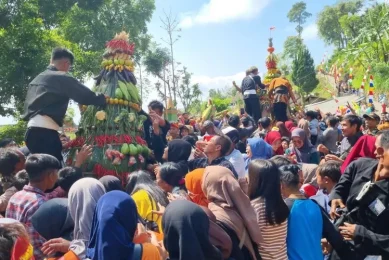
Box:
[161,12,181,104]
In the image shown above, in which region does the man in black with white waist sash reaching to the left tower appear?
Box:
[22,48,106,162]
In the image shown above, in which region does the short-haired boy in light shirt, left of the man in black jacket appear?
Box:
[311,161,341,213]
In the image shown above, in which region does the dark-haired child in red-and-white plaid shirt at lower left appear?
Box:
[6,154,61,259]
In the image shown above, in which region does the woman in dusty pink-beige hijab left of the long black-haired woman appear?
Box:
[202,166,263,260]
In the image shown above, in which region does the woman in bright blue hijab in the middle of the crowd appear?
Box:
[243,137,273,172]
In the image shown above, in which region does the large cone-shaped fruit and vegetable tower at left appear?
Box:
[67,32,150,181]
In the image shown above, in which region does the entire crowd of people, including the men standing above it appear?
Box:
[0,49,389,260]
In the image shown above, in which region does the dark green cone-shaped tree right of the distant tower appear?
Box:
[292,48,319,93]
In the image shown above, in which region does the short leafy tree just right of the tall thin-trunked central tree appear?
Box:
[177,67,201,111]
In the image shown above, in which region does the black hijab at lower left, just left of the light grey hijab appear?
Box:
[31,198,74,241]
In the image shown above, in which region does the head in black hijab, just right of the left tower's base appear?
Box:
[162,139,192,162]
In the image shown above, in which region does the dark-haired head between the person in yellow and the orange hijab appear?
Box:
[156,162,184,192]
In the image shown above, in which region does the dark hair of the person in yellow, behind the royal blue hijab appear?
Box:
[126,171,169,207]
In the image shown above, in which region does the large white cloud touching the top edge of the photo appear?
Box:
[180,0,271,28]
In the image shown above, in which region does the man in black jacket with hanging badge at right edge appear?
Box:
[330,131,389,259]
